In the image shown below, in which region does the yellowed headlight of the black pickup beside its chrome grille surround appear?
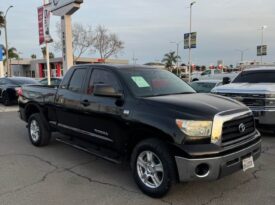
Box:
[176,119,212,138]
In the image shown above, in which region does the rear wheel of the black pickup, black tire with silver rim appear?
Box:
[28,113,51,147]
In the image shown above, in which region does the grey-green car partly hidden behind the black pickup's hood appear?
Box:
[190,80,223,93]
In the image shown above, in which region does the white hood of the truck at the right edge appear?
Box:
[212,83,275,94]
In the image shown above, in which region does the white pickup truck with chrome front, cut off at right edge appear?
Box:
[212,67,275,132]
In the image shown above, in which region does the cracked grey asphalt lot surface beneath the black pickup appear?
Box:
[0,106,275,205]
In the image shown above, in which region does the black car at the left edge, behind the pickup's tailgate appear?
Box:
[0,77,39,106]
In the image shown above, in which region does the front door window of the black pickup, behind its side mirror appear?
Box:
[87,69,121,95]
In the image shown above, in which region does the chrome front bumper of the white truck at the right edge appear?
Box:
[250,107,275,125]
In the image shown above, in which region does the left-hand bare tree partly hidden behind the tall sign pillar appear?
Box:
[54,23,94,62]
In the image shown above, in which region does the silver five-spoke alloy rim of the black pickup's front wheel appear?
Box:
[136,151,164,188]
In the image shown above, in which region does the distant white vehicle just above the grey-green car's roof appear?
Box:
[191,69,238,81]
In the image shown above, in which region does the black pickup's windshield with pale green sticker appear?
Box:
[121,68,195,97]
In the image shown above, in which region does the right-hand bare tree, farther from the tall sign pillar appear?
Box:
[94,25,124,59]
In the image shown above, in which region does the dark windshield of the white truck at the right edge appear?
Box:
[232,70,275,83]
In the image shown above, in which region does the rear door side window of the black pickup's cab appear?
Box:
[68,68,86,92]
